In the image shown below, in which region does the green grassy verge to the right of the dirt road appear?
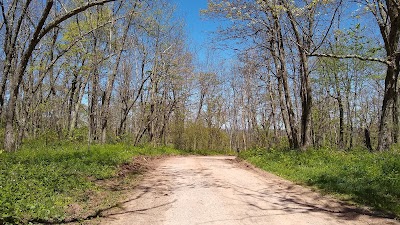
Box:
[241,149,400,218]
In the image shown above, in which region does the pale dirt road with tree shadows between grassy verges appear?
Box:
[102,157,400,225]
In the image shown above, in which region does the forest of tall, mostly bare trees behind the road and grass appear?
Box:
[0,0,400,151]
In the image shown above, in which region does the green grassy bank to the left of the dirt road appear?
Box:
[0,144,186,224]
